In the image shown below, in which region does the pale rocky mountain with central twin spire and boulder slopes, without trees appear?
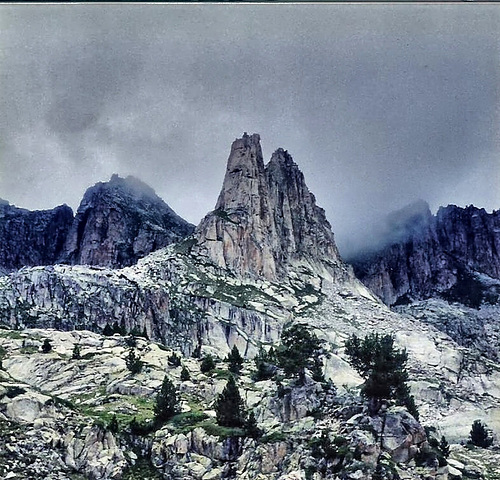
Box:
[0,135,500,480]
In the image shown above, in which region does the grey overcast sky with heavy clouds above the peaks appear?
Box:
[0,3,500,253]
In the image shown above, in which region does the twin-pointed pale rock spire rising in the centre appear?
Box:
[196,133,342,281]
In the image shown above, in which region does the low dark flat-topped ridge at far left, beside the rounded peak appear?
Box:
[0,200,73,272]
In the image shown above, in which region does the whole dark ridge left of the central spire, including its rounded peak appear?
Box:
[0,175,194,274]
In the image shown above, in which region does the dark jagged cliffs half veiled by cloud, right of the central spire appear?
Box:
[350,202,500,307]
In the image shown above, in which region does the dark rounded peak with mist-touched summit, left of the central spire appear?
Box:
[61,175,194,268]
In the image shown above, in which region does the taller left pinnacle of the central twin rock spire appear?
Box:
[196,134,277,279]
